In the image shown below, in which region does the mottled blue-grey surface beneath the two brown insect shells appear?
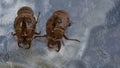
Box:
[0,0,120,68]
